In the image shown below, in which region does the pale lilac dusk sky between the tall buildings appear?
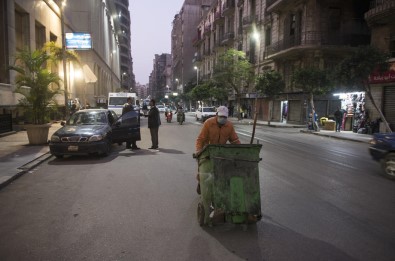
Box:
[129,0,184,84]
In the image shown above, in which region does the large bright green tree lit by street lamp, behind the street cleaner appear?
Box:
[213,49,254,117]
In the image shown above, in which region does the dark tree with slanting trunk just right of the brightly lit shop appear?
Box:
[335,46,392,132]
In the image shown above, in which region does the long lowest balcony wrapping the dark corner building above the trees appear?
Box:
[267,31,370,55]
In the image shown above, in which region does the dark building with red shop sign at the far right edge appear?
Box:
[365,0,395,131]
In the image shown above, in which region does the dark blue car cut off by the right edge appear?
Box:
[369,133,395,180]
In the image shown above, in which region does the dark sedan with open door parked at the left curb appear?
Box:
[49,109,141,158]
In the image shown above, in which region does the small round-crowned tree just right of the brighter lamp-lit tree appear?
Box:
[255,70,285,125]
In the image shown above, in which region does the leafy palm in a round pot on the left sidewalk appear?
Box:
[10,49,60,145]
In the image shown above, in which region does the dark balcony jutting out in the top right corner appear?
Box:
[365,0,395,26]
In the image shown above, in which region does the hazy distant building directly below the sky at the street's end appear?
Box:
[149,53,172,102]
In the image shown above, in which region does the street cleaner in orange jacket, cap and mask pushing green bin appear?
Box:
[195,106,240,195]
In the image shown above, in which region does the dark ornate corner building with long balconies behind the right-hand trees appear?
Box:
[195,0,382,127]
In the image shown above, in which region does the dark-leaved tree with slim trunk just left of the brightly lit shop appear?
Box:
[292,67,333,130]
